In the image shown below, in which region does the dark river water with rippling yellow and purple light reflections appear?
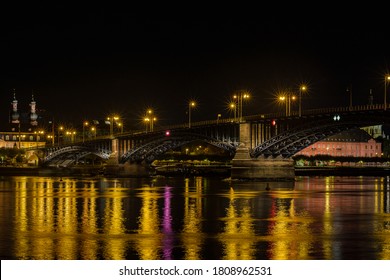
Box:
[0,176,390,260]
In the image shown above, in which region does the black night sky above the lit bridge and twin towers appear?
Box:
[0,4,390,128]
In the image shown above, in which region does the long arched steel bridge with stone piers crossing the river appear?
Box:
[30,104,390,178]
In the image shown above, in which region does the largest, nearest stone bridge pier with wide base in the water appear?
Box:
[231,123,295,181]
